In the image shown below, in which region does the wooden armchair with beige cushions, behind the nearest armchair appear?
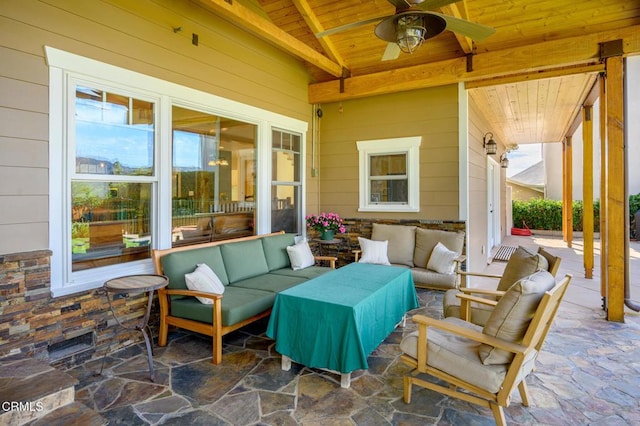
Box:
[442,247,562,326]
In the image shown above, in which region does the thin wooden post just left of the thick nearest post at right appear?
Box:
[599,74,608,302]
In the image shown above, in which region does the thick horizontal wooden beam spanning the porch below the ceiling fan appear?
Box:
[309,25,640,104]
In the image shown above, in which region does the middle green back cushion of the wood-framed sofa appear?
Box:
[220,239,269,283]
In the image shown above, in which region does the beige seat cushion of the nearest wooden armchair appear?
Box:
[400,317,516,393]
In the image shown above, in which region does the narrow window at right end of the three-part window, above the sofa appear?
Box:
[271,130,302,233]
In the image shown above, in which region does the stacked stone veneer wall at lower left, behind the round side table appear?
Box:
[0,250,159,367]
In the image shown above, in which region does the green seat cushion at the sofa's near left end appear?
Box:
[171,286,276,326]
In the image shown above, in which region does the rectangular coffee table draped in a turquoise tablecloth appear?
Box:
[267,263,419,387]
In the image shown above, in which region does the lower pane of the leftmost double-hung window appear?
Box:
[71,181,152,271]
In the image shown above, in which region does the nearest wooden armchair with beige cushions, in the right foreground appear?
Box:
[400,271,571,425]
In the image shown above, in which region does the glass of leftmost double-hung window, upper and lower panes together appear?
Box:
[68,87,155,271]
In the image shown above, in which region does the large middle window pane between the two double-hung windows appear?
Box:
[172,106,256,246]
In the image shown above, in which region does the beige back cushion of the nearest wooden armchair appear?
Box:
[479,271,556,365]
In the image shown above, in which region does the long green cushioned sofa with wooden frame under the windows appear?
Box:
[153,232,336,364]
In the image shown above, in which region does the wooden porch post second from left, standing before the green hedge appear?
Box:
[582,106,593,278]
